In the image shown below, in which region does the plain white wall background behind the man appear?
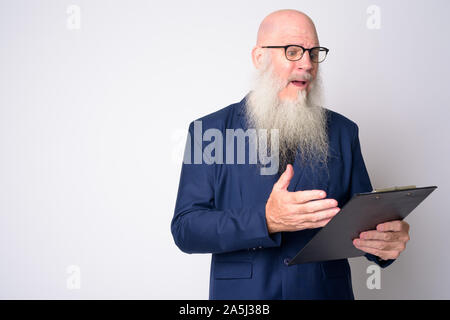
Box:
[0,0,450,299]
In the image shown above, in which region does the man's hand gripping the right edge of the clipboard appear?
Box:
[353,220,410,260]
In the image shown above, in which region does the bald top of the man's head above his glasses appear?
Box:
[256,10,319,46]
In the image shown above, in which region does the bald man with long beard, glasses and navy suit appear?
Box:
[171,10,409,299]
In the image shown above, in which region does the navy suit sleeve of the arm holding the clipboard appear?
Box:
[350,125,395,268]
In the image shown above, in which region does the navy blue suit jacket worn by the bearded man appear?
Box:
[171,98,392,299]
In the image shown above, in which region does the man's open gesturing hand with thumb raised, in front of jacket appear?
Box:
[266,164,340,233]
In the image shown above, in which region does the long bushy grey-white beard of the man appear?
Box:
[246,66,328,172]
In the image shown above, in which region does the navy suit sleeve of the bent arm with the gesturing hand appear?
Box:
[171,123,281,253]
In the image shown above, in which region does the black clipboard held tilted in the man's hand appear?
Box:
[288,186,437,266]
